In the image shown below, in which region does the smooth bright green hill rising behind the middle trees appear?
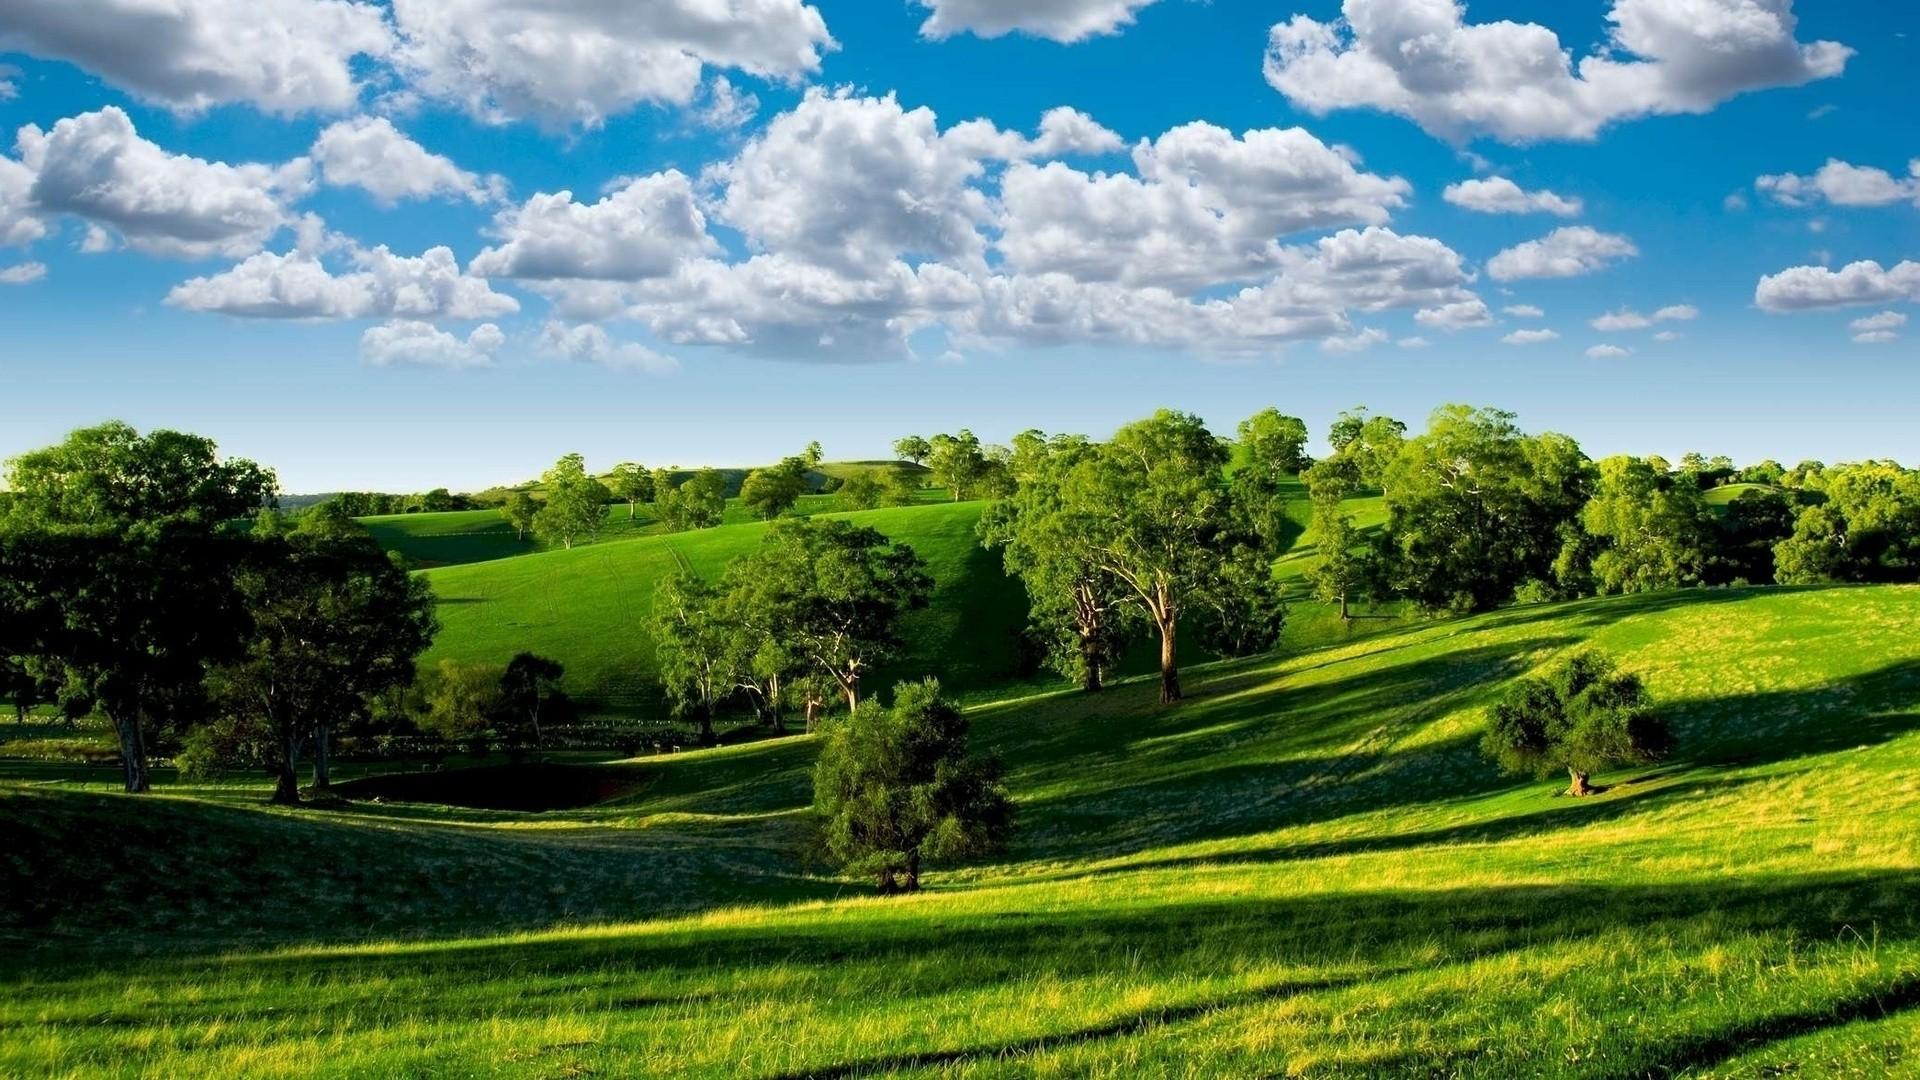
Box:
[424,503,1025,717]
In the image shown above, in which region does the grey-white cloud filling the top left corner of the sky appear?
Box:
[0,0,392,115]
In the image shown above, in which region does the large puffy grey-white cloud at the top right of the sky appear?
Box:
[1265,0,1853,142]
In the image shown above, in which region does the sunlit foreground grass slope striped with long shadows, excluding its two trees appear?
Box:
[0,576,1920,1078]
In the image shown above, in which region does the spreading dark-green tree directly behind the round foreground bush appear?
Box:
[730,519,933,711]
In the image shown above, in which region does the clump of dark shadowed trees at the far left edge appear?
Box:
[0,423,436,798]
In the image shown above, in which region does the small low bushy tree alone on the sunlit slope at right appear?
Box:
[1480,651,1672,796]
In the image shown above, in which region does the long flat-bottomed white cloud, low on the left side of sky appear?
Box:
[167,246,520,321]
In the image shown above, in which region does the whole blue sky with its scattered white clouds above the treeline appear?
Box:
[0,0,1920,492]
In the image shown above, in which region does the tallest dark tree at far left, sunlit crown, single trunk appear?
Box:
[0,423,275,792]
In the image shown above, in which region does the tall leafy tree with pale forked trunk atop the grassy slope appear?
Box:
[1052,409,1260,703]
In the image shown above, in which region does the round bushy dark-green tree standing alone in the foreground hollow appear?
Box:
[814,678,1014,894]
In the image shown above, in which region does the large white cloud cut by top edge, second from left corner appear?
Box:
[394,0,835,127]
